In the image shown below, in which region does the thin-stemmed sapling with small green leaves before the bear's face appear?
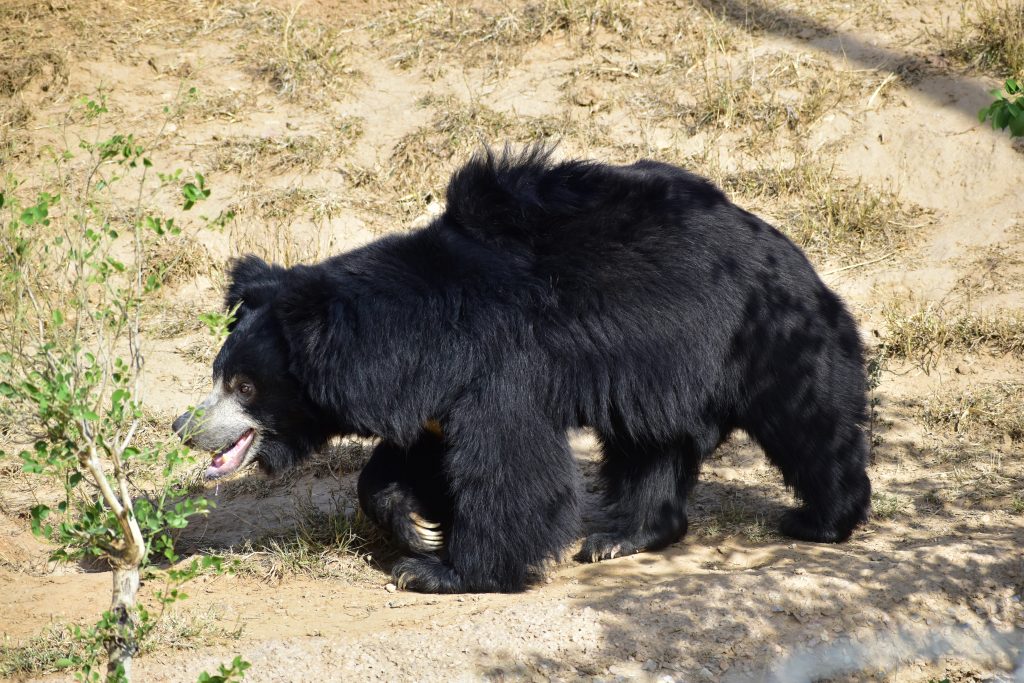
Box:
[0,93,245,682]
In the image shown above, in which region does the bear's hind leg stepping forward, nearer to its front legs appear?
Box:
[577,435,705,562]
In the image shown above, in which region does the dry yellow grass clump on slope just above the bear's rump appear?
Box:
[722,161,924,261]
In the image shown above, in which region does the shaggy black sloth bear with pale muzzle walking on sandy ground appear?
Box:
[174,147,870,593]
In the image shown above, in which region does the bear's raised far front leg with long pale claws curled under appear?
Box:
[357,432,452,553]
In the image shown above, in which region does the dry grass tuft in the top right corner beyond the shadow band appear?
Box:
[940,0,1024,78]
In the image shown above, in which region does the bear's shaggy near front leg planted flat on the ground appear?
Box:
[392,400,580,593]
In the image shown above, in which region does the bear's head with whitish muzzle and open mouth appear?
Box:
[173,256,331,479]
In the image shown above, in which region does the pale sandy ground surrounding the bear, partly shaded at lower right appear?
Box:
[0,0,1024,681]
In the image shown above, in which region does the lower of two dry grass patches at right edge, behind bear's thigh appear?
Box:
[921,382,1024,443]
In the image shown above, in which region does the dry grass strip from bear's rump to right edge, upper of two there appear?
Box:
[881,300,1024,369]
